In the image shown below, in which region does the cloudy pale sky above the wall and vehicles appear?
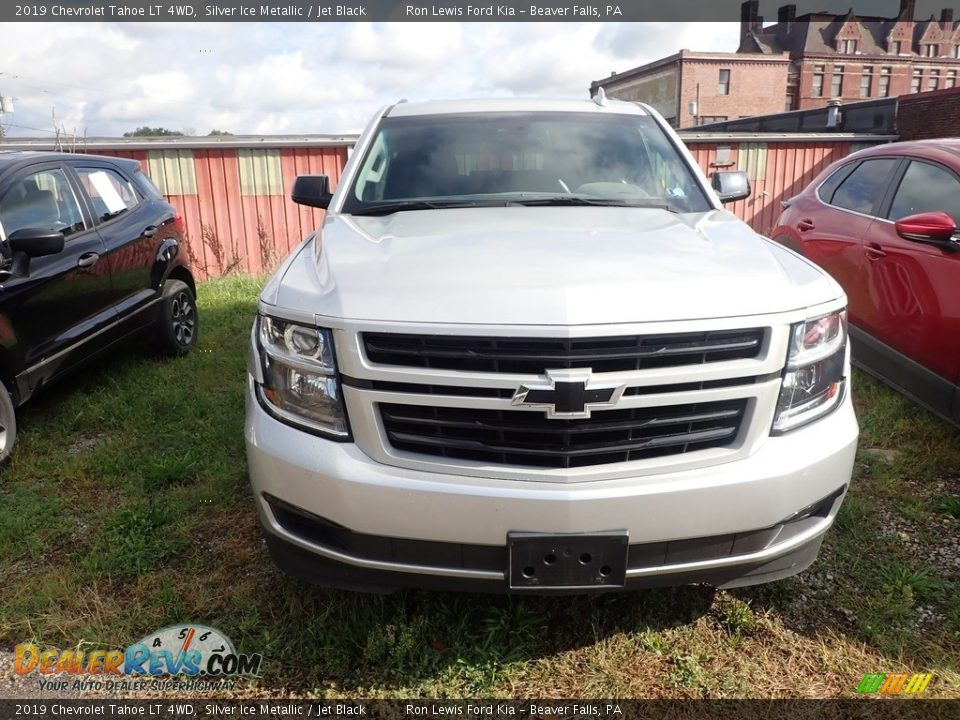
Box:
[0,22,739,137]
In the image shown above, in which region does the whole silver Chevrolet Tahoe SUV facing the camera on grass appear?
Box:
[246,99,857,593]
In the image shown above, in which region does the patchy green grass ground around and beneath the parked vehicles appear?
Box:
[0,277,960,698]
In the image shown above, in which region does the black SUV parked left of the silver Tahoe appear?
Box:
[0,152,197,463]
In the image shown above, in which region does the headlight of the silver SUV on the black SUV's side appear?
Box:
[257,315,350,439]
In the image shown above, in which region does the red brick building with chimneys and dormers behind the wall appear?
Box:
[590,0,960,127]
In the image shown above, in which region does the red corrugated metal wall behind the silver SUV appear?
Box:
[90,138,872,278]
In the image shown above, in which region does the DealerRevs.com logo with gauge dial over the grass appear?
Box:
[13,625,263,689]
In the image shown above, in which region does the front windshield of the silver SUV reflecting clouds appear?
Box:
[343,112,711,214]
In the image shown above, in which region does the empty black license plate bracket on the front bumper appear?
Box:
[507,530,629,590]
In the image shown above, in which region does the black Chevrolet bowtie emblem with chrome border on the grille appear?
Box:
[510,369,626,420]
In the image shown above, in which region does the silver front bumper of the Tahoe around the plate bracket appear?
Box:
[246,376,857,592]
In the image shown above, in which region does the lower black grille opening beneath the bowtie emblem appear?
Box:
[380,400,746,468]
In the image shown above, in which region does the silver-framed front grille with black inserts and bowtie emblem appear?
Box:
[335,316,793,483]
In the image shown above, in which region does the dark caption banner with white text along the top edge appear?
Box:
[0,0,928,22]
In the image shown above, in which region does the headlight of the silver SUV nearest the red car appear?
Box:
[772,310,847,434]
